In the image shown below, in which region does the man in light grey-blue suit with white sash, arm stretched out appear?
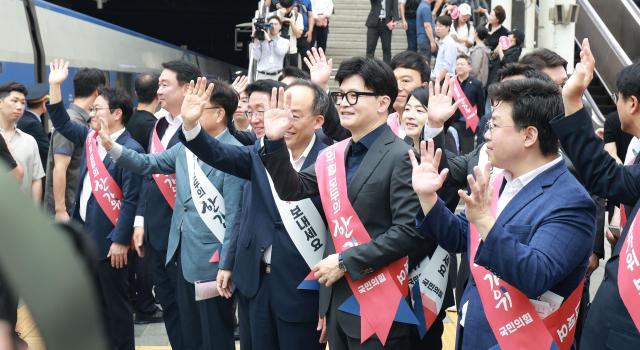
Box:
[100,79,244,350]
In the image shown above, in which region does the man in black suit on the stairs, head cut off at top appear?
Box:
[365,0,400,64]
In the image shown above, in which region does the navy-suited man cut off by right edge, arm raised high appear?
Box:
[551,39,640,350]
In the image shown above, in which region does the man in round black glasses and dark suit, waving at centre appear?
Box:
[262,58,420,350]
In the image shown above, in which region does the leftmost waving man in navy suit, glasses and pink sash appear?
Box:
[47,60,143,350]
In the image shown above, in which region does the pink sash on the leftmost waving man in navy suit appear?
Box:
[85,130,122,226]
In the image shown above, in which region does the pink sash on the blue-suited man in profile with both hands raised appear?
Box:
[470,175,584,350]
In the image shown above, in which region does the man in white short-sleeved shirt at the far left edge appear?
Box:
[0,82,44,203]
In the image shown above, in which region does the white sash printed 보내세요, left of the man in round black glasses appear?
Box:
[265,169,327,269]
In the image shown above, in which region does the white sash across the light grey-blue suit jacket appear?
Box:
[184,147,227,243]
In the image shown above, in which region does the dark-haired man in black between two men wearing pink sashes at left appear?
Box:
[127,74,160,152]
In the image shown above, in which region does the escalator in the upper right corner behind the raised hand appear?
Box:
[575,0,640,126]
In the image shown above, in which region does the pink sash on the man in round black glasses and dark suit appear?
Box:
[315,139,408,345]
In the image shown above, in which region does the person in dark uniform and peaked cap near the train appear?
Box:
[16,83,49,167]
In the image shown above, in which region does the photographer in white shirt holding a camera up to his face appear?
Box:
[251,16,289,80]
